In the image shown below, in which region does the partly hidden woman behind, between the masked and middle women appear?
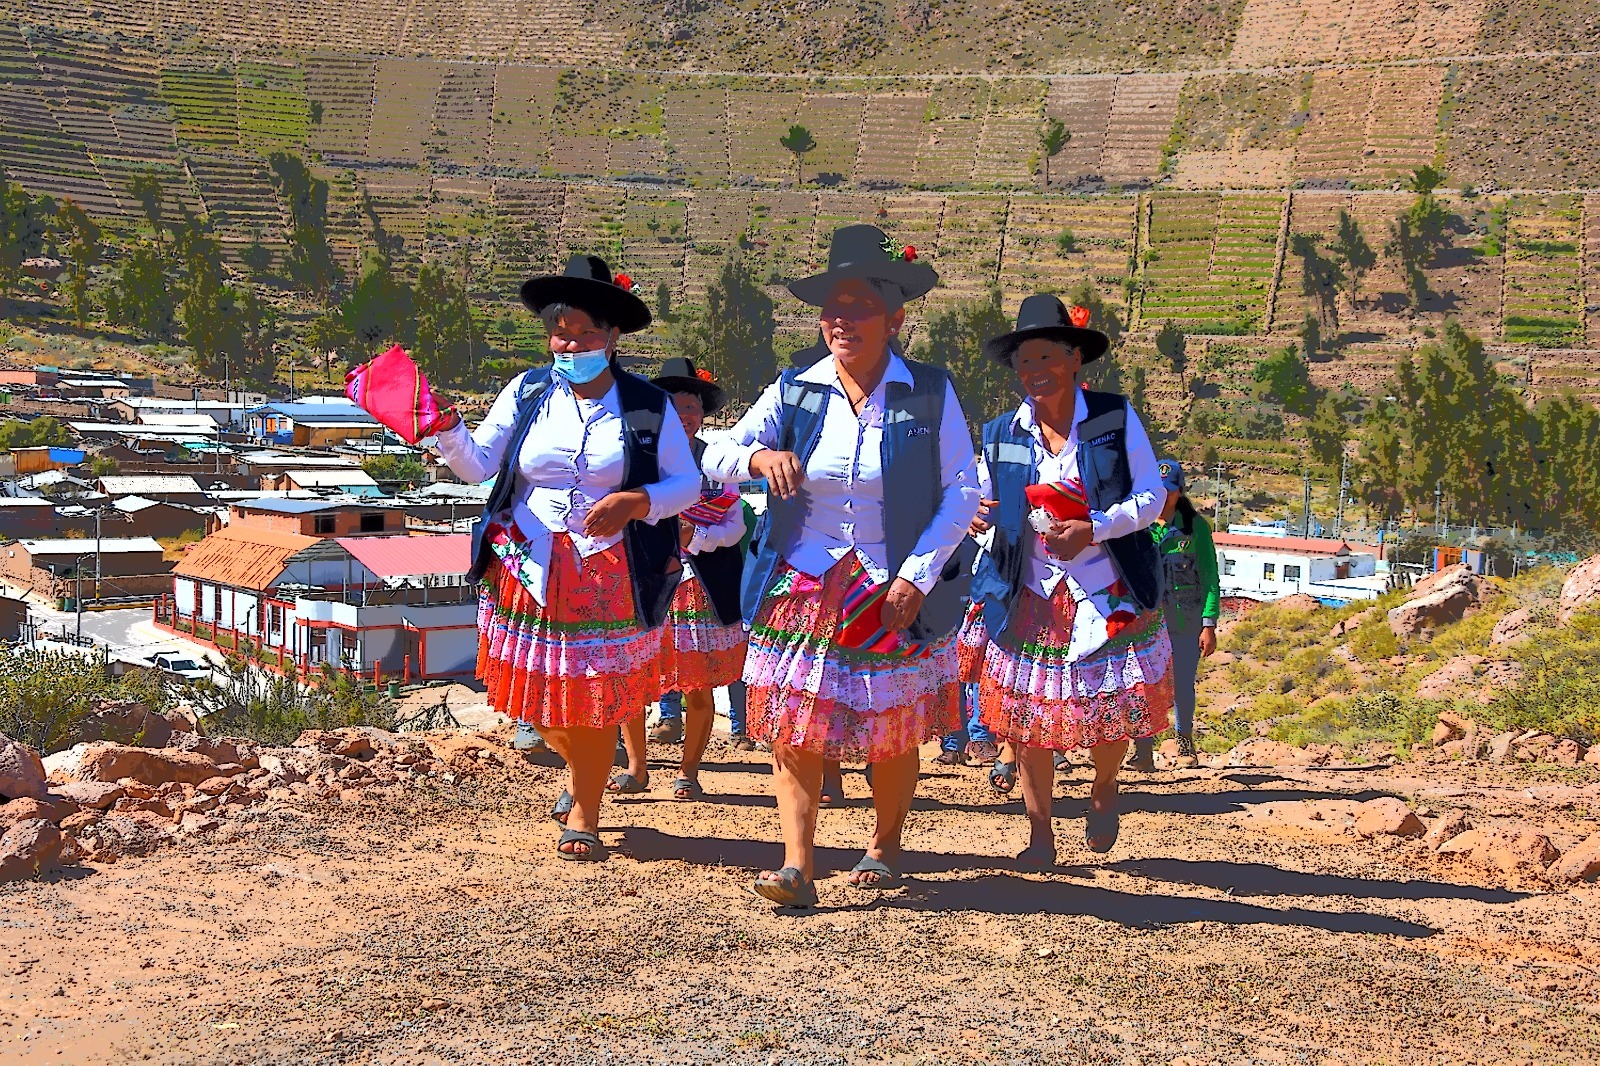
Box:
[606,359,746,800]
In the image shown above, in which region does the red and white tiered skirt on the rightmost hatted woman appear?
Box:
[978,581,1173,751]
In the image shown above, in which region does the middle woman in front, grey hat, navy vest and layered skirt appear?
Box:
[704,226,978,906]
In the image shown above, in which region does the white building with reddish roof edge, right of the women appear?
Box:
[1214,530,1387,605]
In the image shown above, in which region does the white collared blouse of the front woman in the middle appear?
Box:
[701,354,979,592]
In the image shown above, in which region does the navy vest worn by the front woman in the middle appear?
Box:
[742,359,972,642]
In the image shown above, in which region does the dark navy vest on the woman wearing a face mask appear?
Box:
[467,367,683,629]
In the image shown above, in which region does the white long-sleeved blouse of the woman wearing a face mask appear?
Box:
[437,375,701,605]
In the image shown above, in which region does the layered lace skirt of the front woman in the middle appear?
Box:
[744,557,960,762]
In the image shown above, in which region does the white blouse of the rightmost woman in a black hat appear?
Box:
[978,391,1166,600]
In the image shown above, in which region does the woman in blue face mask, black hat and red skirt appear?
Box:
[438,256,701,860]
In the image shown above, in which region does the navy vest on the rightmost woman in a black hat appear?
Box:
[973,392,1166,637]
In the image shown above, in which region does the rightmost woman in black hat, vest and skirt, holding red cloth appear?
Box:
[973,295,1173,868]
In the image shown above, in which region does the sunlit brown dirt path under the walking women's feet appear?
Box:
[0,749,1600,1066]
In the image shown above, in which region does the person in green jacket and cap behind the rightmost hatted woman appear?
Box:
[1130,459,1222,770]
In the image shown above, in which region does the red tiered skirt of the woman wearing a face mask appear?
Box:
[478,527,661,728]
